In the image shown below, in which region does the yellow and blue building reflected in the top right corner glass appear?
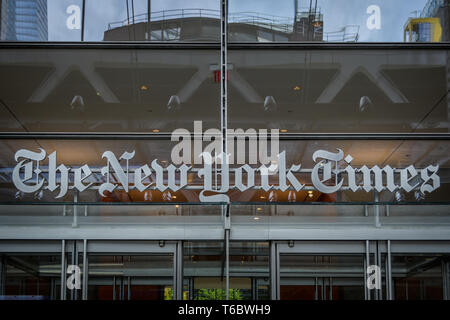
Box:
[403,0,450,42]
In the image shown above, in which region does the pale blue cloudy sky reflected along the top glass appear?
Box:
[48,0,427,42]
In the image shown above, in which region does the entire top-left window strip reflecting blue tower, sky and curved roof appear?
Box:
[0,0,220,42]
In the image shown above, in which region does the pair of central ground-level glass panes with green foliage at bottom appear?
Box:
[183,242,269,300]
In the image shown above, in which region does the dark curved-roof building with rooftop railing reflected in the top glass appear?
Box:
[104,7,359,42]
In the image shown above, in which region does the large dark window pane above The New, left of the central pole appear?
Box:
[0,48,220,133]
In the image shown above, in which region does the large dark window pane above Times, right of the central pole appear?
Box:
[228,50,450,133]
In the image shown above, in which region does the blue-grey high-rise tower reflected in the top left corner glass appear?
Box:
[0,0,48,41]
